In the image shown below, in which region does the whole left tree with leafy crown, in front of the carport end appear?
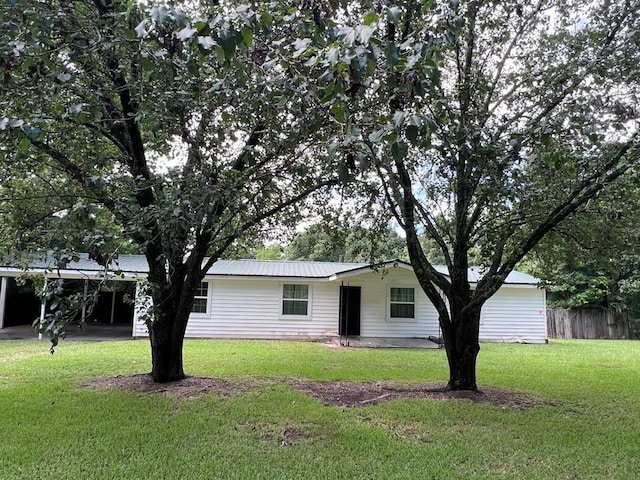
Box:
[0,0,346,382]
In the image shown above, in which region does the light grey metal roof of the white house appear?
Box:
[0,253,539,285]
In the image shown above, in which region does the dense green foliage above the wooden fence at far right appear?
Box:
[523,172,640,318]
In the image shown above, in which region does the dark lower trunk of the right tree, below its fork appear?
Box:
[442,305,480,390]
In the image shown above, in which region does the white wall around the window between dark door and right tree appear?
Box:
[343,268,438,338]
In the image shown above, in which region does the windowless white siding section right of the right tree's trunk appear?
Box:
[480,285,547,343]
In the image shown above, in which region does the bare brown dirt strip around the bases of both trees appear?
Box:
[85,374,559,410]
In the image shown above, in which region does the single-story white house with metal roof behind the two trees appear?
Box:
[0,255,547,343]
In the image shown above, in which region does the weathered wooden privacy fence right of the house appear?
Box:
[547,308,631,339]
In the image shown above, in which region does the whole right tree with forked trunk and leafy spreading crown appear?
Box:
[308,0,640,389]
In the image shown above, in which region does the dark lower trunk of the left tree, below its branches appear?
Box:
[149,312,189,383]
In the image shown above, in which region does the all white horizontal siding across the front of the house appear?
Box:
[133,268,547,343]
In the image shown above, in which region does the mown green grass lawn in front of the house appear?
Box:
[0,340,640,480]
